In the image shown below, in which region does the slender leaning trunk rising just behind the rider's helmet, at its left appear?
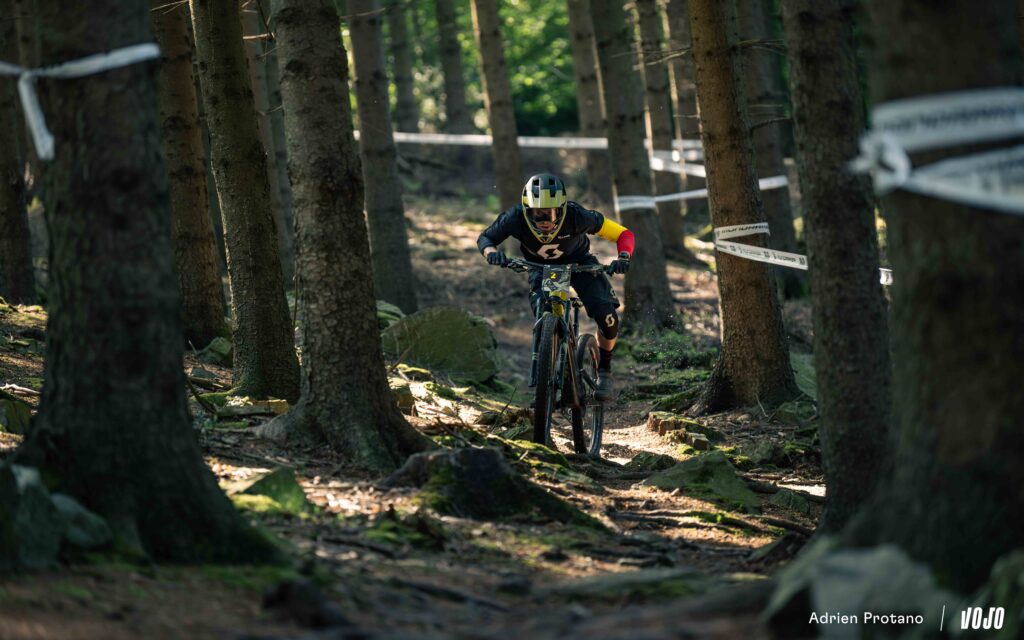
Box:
[469,0,523,209]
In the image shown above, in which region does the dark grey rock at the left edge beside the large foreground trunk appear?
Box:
[0,463,65,569]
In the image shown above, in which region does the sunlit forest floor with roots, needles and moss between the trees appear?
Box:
[0,200,824,638]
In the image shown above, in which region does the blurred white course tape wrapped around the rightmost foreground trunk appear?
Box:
[850,87,1024,214]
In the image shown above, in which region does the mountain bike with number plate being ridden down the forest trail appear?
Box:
[505,258,608,458]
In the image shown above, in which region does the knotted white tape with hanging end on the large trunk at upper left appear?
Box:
[0,43,160,161]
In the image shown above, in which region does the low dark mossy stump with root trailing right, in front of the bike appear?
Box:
[383,447,604,529]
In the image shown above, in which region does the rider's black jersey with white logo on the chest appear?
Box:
[476,201,604,264]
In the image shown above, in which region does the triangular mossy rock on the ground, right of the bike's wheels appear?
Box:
[643,451,761,513]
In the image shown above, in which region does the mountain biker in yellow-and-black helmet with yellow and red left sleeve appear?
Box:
[476,173,635,400]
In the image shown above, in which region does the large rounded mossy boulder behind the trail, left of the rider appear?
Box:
[381,307,498,382]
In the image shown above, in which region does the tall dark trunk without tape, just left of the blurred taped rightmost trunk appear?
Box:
[782,0,892,531]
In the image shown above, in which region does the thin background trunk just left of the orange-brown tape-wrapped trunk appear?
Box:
[665,0,708,215]
